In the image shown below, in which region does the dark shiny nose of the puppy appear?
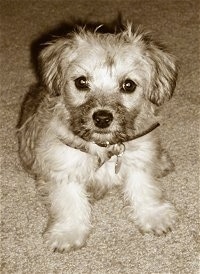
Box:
[92,110,113,128]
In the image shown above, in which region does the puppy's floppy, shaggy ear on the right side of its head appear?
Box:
[145,42,177,106]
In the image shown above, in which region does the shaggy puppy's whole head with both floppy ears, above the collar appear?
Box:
[41,26,177,143]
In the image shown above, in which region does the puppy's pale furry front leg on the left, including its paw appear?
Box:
[45,181,91,252]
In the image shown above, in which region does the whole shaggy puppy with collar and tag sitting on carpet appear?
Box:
[18,23,177,252]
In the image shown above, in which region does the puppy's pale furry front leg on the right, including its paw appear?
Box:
[124,170,176,235]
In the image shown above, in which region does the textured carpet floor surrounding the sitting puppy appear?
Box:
[0,0,200,274]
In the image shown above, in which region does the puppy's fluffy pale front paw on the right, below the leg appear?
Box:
[135,203,177,236]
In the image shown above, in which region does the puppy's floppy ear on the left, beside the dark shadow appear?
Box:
[39,38,71,96]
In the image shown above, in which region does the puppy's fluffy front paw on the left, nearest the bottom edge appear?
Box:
[44,223,89,253]
